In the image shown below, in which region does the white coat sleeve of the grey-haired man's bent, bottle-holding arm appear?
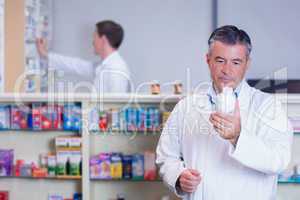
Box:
[229,99,293,174]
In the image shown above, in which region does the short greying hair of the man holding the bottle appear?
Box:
[208,25,252,57]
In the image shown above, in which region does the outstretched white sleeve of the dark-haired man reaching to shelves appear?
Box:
[48,52,94,79]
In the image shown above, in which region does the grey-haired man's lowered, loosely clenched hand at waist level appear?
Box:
[179,169,201,193]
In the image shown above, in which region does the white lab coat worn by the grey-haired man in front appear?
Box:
[156,81,293,200]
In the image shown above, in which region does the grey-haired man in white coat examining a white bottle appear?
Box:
[156,26,293,200]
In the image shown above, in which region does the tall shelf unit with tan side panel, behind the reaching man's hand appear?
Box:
[1,0,52,92]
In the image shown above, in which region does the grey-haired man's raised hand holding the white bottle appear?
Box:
[209,100,241,146]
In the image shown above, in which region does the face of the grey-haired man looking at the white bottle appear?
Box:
[207,41,250,92]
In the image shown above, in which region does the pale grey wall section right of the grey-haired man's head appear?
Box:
[218,0,300,79]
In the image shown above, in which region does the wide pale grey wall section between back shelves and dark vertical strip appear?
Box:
[53,0,212,92]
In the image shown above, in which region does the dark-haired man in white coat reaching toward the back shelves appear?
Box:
[37,20,130,93]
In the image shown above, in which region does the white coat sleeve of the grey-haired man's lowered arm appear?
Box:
[156,102,186,197]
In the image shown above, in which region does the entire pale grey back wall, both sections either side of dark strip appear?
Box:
[44,0,300,91]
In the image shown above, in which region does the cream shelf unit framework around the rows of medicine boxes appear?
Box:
[0,94,300,200]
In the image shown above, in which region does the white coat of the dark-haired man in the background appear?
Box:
[48,51,130,93]
